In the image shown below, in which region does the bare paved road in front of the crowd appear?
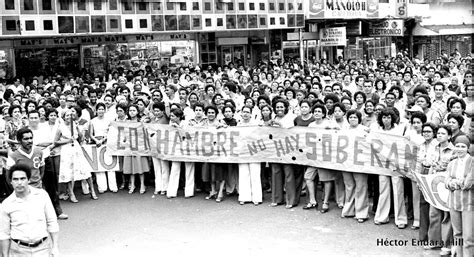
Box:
[60,191,438,256]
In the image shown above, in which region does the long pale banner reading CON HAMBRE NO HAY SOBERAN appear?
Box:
[107,122,418,176]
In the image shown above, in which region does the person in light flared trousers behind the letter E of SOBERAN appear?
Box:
[341,110,369,223]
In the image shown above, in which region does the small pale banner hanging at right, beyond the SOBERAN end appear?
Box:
[413,172,449,211]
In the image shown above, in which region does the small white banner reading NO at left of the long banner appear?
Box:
[61,145,119,172]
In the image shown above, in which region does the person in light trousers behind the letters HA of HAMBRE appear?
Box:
[150,102,170,195]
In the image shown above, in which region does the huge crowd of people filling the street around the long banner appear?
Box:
[0,52,474,256]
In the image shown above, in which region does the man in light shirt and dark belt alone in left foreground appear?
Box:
[0,164,59,256]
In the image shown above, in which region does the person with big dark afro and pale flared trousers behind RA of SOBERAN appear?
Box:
[374,108,408,229]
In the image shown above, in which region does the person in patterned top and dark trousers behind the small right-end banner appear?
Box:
[425,125,454,255]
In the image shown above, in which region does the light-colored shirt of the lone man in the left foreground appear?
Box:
[0,186,59,242]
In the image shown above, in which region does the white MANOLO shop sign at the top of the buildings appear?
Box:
[309,0,379,19]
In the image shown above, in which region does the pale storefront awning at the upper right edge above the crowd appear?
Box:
[413,24,474,36]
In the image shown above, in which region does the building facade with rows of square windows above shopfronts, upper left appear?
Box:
[0,0,305,78]
